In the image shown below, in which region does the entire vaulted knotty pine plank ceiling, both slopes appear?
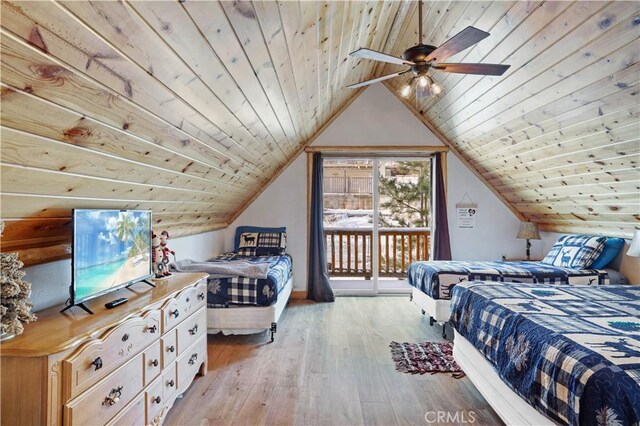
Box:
[0,1,640,264]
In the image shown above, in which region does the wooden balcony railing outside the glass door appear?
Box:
[324,228,431,279]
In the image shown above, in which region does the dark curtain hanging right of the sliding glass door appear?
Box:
[431,152,451,260]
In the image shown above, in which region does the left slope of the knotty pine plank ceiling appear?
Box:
[0,1,406,257]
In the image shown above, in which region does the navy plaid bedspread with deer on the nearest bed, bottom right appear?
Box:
[451,282,640,426]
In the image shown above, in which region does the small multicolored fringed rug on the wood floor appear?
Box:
[389,342,465,379]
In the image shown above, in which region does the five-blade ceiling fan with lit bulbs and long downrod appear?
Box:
[347,1,510,98]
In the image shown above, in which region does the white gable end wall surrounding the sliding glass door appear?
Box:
[227,85,524,290]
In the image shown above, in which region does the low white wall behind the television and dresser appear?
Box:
[25,230,225,312]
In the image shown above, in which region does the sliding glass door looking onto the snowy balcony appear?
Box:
[323,157,431,295]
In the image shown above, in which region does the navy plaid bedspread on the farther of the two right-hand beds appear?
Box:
[407,260,609,299]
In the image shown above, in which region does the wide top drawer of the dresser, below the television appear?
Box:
[62,310,161,402]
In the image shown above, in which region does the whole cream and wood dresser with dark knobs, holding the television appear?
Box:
[0,273,207,425]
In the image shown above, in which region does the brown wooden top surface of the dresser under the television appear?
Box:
[0,273,208,357]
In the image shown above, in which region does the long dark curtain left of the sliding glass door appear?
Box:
[307,153,335,302]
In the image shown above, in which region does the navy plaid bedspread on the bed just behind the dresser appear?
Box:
[207,253,292,308]
